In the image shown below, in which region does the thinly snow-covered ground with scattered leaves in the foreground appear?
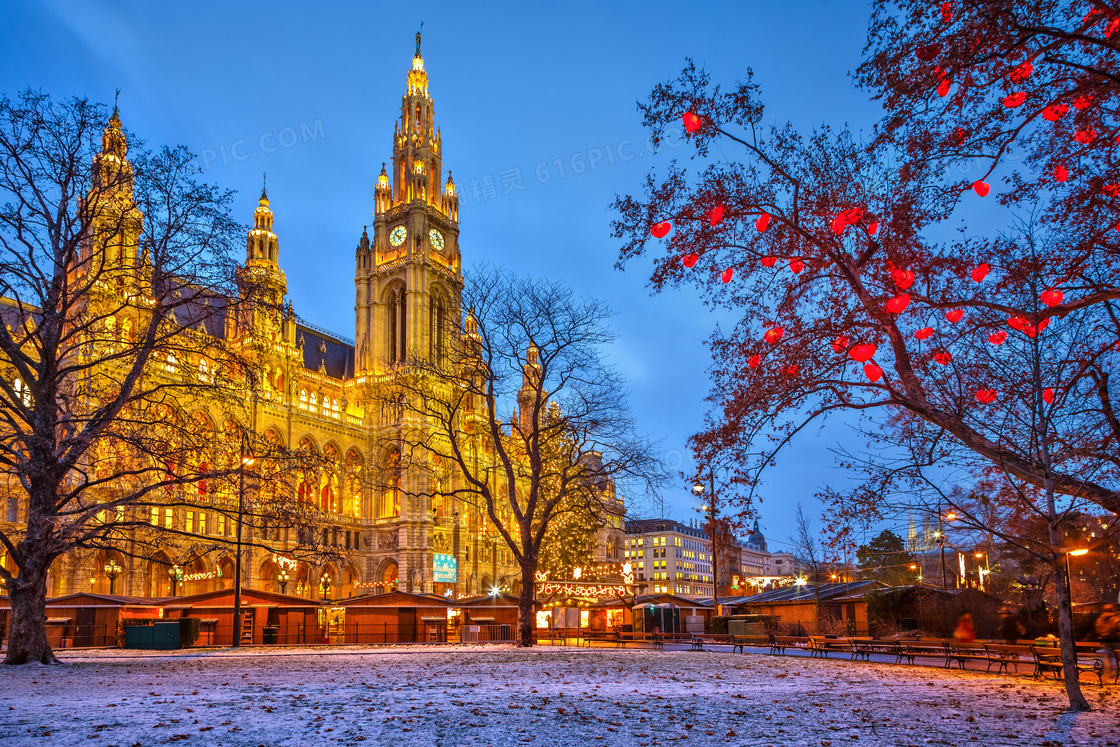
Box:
[0,647,1120,747]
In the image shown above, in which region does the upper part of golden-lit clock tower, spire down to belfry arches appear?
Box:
[354,34,463,375]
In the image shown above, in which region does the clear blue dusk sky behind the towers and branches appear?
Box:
[0,0,891,548]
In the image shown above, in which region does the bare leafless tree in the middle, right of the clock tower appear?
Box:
[383,268,664,646]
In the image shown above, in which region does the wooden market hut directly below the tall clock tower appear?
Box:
[330,591,452,643]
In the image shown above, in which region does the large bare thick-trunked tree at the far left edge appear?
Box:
[0,92,331,664]
